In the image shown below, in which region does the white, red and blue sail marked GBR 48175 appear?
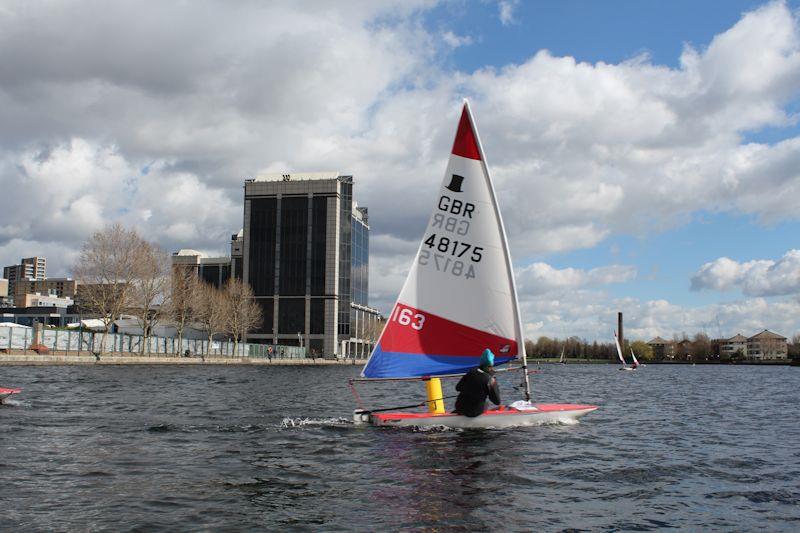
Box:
[362,105,523,377]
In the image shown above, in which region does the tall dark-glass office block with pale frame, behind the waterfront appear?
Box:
[241,172,379,357]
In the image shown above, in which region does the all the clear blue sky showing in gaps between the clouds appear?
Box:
[418,1,800,336]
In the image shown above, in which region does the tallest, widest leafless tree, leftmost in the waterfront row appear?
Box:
[72,224,146,351]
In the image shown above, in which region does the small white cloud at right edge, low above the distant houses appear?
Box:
[692,250,800,296]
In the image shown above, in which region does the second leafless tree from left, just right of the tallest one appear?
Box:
[128,241,171,354]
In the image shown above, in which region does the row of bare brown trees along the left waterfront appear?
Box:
[73,224,262,353]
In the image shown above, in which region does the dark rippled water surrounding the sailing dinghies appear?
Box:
[0,365,800,531]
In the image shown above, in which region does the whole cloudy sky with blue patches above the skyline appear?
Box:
[0,0,800,342]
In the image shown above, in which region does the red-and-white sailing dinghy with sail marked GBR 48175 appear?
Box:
[351,100,597,428]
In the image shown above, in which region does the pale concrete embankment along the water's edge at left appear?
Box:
[0,351,366,366]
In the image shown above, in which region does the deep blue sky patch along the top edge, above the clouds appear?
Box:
[426,0,797,67]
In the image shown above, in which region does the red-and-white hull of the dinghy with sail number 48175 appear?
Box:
[353,403,597,429]
